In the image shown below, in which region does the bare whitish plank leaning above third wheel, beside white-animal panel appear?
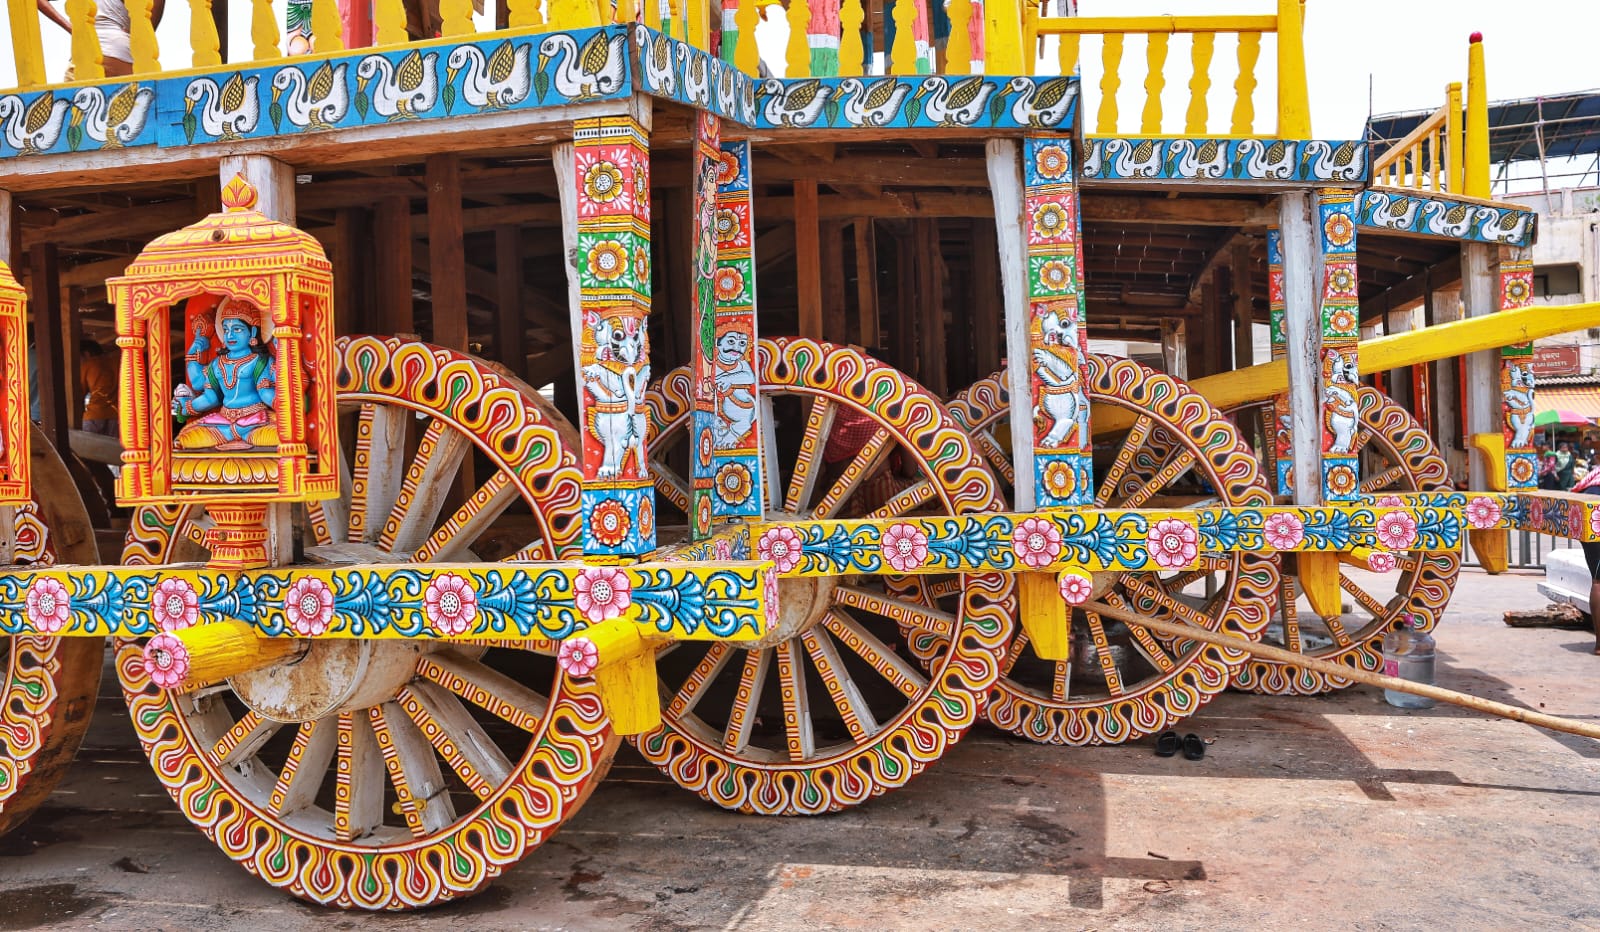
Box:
[984,139,1035,511]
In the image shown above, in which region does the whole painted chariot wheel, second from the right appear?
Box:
[934,356,1278,745]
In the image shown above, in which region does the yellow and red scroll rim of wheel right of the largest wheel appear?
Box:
[635,339,1011,815]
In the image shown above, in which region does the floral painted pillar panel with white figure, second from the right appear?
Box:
[1317,189,1362,504]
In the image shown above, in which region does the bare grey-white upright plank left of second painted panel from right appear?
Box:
[1278,191,1322,504]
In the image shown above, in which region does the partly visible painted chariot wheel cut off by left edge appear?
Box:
[0,429,106,834]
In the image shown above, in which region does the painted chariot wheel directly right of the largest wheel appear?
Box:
[635,339,1010,815]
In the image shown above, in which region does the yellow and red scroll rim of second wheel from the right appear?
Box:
[947,361,1278,745]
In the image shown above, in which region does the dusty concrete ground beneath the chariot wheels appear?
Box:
[0,573,1600,932]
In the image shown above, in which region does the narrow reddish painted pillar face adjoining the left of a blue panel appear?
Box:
[690,110,722,540]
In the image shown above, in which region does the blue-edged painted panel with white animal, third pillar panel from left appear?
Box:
[712,143,766,517]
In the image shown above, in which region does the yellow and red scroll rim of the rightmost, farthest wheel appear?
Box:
[1234,386,1461,695]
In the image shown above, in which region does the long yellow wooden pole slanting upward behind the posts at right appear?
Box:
[1094,301,1600,434]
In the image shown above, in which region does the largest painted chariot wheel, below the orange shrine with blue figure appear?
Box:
[117,336,616,910]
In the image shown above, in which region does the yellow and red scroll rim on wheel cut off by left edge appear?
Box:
[0,509,55,812]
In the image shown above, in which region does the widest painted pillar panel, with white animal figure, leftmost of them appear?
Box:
[573,117,656,557]
